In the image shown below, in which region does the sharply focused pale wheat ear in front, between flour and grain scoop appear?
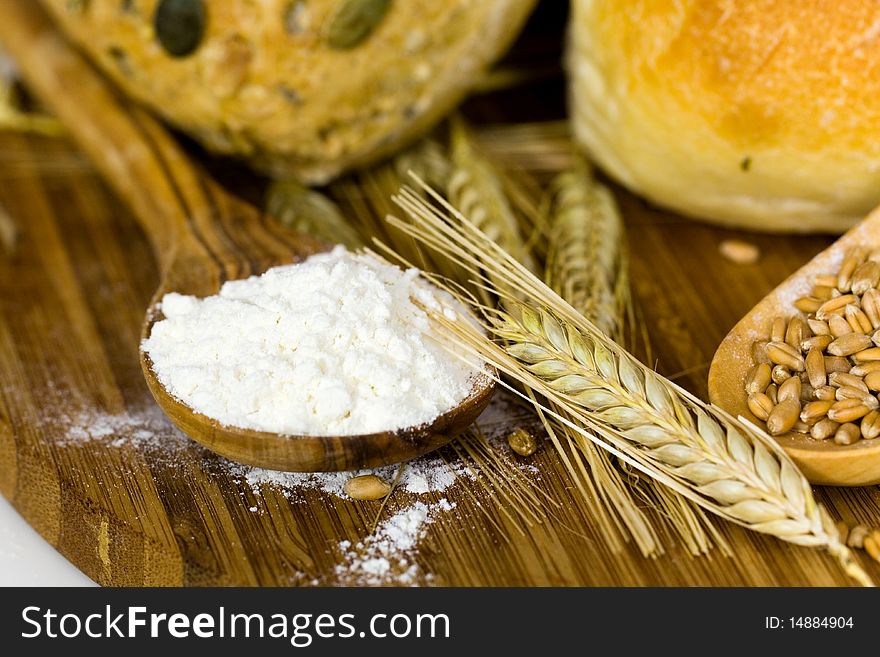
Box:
[389,179,872,586]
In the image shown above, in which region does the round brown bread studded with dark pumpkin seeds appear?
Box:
[43,0,536,183]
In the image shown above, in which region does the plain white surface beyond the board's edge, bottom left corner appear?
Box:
[0,495,95,586]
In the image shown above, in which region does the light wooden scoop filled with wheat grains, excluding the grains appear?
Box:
[709,210,880,486]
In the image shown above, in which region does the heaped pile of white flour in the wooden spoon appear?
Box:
[141,247,481,435]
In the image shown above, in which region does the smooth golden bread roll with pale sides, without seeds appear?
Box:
[568,0,880,232]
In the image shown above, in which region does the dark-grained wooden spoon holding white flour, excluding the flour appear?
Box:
[0,2,494,472]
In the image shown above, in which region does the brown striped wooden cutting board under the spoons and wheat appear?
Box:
[0,124,880,586]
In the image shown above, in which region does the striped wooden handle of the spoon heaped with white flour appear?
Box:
[0,1,308,278]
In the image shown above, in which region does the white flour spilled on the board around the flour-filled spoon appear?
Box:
[48,394,537,586]
